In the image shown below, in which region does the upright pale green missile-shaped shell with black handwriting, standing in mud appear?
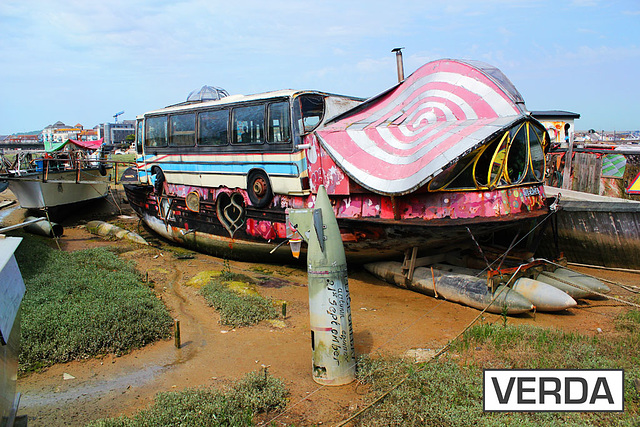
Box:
[289,186,356,385]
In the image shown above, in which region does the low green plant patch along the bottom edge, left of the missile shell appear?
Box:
[89,371,288,427]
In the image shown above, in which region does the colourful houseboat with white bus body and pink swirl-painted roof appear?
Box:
[123,60,549,261]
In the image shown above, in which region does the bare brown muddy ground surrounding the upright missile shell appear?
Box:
[0,189,640,426]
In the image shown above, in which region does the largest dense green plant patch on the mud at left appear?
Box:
[16,236,172,373]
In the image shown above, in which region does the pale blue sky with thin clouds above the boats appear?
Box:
[0,0,640,135]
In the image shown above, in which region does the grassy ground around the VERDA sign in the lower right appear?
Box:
[357,310,640,426]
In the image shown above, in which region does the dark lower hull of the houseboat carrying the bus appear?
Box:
[124,184,547,263]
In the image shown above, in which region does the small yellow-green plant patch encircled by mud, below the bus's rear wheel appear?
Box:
[200,271,278,327]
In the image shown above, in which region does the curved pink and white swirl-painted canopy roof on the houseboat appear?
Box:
[316,59,528,195]
